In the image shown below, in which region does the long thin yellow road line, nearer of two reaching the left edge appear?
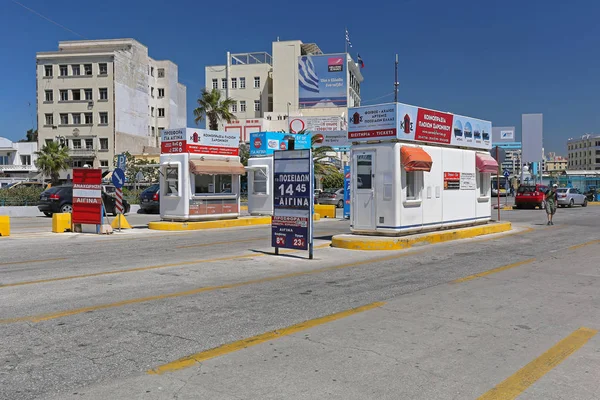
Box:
[0,244,425,324]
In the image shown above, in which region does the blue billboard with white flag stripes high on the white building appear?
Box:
[298,54,348,108]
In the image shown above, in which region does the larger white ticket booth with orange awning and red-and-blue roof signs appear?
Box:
[348,103,498,236]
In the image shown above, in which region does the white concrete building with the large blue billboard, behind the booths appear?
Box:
[205,40,363,142]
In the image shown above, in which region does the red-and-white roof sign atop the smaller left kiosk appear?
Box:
[160,128,240,156]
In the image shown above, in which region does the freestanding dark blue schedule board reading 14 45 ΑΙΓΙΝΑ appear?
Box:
[271,149,314,260]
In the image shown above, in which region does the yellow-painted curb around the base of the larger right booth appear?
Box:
[331,222,512,250]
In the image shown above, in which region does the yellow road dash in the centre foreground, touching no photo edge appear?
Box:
[146,302,385,375]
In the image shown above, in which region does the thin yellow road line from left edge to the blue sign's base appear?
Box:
[0,242,331,289]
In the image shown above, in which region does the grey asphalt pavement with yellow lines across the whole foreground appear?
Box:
[0,207,600,400]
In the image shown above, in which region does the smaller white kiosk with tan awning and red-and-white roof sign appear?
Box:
[160,128,246,221]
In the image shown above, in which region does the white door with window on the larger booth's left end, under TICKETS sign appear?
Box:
[350,151,375,231]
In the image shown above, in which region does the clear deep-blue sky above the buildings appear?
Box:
[0,0,600,155]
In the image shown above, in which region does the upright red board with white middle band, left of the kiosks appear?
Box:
[71,168,102,225]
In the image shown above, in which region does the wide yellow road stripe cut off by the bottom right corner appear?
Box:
[477,327,598,400]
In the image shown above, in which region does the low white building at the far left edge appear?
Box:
[0,137,38,187]
